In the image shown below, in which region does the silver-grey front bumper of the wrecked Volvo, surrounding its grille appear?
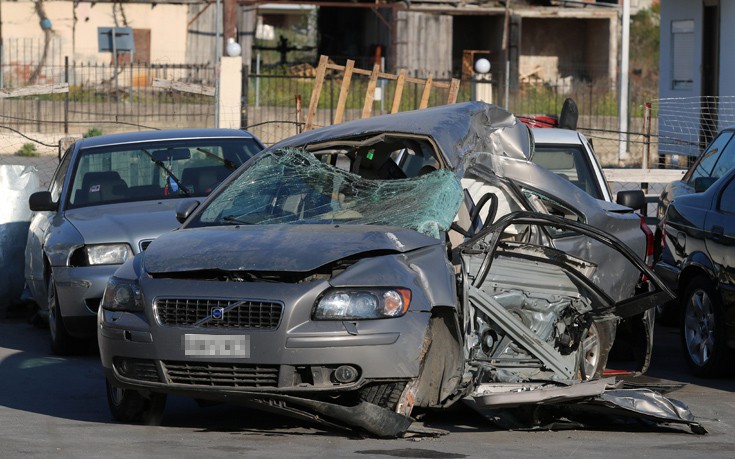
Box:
[98,279,431,400]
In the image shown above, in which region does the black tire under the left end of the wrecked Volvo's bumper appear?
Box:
[105,379,166,426]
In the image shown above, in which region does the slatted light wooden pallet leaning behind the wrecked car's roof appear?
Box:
[304,55,459,131]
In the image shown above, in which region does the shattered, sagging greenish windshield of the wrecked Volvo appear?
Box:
[189,149,463,238]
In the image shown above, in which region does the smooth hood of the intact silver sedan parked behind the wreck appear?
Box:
[64,199,181,245]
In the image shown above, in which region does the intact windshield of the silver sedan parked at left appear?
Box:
[68,139,260,208]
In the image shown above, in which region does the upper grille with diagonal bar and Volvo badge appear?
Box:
[155,298,283,330]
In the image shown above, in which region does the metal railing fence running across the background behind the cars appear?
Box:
[0,61,680,214]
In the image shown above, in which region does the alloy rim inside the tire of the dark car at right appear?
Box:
[684,289,715,366]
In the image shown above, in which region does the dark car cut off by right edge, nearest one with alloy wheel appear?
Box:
[655,168,735,377]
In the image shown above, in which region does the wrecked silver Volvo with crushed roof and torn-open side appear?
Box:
[98,103,688,437]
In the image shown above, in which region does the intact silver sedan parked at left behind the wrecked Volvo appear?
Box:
[25,129,263,354]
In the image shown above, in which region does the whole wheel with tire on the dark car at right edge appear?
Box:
[680,276,728,378]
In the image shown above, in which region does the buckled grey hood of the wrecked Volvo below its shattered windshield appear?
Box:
[143,225,441,274]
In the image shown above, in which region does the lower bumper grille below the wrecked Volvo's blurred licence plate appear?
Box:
[161,361,279,388]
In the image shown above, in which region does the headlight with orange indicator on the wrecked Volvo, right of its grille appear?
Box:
[314,288,411,320]
